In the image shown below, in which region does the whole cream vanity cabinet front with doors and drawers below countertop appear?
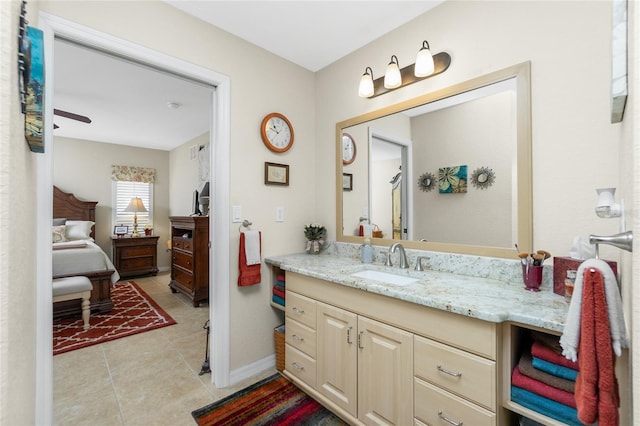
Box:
[285,272,506,425]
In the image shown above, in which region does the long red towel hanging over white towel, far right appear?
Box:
[575,268,620,426]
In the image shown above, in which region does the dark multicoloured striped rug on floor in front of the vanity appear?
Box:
[191,373,347,426]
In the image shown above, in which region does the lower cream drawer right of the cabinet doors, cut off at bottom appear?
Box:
[414,378,496,426]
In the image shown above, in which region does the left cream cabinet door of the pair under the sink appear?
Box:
[317,303,358,417]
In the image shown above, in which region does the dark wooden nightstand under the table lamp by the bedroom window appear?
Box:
[111,236,159,277]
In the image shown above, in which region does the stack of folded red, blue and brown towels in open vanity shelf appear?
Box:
[511,332,582,426]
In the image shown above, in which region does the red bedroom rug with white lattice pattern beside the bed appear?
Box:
[53,281,176,355]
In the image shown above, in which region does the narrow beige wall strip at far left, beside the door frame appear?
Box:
[0,1,38,425]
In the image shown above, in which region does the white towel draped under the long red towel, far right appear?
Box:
[560,259,629,362]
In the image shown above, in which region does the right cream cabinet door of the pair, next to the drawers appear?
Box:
[358,317,413,426]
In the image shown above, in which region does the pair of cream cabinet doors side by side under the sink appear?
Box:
[317,302,413,425]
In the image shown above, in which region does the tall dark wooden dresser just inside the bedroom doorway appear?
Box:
[169,216,209,307]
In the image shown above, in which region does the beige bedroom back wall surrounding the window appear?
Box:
[53,137,170,270]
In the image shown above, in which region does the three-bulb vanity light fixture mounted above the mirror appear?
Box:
[358,40,451,98]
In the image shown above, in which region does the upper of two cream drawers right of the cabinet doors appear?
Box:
[414,336,496,411]
